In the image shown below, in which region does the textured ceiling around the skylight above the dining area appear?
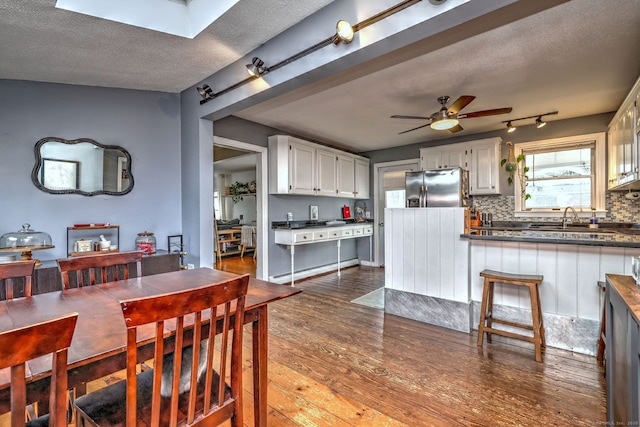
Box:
[0,0,332,93]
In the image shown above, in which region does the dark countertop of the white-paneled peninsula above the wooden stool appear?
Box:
[461,221,640,248]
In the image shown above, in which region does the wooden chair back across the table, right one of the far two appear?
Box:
[58,251,142,289]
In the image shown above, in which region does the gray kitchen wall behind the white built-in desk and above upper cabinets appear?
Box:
[213,116,369,276]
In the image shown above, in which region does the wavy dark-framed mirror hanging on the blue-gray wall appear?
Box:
[31,136,133,196]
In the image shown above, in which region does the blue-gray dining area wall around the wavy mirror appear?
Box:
[0,80,182,260]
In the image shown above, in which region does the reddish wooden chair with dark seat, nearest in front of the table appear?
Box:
[75,274,249,427]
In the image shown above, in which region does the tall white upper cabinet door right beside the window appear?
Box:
[469,138,500,195]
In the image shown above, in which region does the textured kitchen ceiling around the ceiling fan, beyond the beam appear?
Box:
[235,0,640,151]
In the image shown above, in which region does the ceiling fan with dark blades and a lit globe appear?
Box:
[391,95,511,135]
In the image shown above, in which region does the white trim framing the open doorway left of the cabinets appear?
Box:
[211,135,269,280]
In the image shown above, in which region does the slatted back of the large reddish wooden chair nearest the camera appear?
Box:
[120,275,249,426]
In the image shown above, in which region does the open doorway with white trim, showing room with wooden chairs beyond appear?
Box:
[213,137,267,279]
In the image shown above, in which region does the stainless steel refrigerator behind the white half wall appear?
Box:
[405,168,469,208]
